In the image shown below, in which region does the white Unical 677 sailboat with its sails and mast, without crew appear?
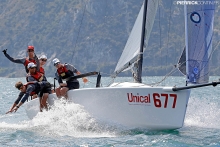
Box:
[22,0,219,130]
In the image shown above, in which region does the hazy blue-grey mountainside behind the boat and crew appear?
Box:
[0,0,220,77]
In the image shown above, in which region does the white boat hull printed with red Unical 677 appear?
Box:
[22,83,190,130]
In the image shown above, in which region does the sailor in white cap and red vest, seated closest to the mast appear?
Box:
[53,58,88,98]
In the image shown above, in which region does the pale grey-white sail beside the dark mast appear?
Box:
[114,0,159,76]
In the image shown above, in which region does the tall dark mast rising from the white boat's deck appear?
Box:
[135,0,148,83]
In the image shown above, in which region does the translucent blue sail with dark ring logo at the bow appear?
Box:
[179,0,215,84]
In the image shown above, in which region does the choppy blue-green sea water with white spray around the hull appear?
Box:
[0,77,220,147]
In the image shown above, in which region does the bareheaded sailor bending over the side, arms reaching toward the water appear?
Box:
[6,81,51,114]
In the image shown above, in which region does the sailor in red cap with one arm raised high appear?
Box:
[2,46,39,73]
